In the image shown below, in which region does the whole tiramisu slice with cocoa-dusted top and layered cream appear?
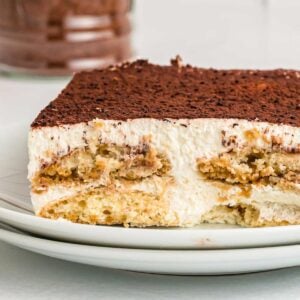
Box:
[29,58,300,227]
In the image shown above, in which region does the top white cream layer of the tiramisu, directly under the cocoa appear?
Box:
[29,119,300,179]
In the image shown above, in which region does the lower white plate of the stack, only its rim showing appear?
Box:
[0,224,300,275]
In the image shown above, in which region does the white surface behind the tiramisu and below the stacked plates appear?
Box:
[0,0,300,300]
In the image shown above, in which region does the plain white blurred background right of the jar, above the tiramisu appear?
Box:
[134,0,300,69]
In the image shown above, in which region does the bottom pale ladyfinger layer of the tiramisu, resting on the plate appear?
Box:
[39,188,300,227]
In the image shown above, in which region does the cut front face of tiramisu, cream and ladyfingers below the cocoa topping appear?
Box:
[29,118,300,226]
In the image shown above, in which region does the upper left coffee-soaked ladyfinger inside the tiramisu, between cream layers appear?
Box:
[32,139,170,192]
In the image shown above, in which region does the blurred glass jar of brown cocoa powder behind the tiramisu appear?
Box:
[0,0,132,75]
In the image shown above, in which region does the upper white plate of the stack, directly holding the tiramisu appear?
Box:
[0,125,300,249]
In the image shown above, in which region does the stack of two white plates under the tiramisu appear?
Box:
[0,125,300,275]
